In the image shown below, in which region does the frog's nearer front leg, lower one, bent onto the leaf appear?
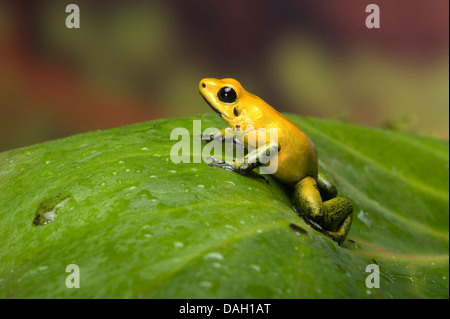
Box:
[208,143,279,183]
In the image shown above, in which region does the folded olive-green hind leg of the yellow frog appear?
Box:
[292,175,353,245]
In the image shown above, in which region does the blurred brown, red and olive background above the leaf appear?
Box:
[0,0,449,151]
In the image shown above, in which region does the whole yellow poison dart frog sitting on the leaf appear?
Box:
[199,78,353,245]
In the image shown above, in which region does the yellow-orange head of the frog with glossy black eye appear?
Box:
[199,78,258,126]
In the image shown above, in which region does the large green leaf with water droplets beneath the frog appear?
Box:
[0,114,449,298]
